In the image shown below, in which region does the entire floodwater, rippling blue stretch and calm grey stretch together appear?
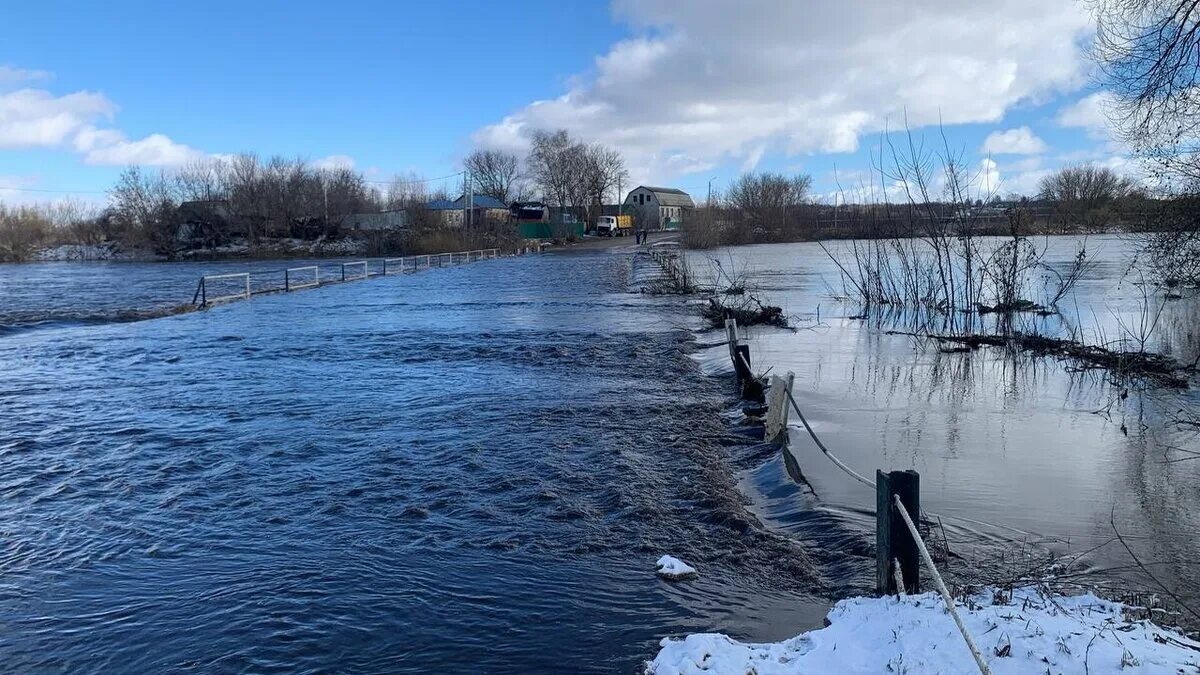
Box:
[0,240,1200,673]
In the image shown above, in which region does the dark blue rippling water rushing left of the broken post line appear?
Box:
[0,253,830,673]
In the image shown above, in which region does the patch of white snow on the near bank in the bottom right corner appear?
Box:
[646,589,1200,675]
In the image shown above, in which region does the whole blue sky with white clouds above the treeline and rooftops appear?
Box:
[0,0,1136,203]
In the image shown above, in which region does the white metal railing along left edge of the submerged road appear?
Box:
[192,247,530,307]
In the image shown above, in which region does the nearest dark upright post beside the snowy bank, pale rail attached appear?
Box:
[875,470,920,596]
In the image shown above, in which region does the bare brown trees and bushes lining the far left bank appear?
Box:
[0,154,516,262]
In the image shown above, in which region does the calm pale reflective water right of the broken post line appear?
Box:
[694,237,1200,607]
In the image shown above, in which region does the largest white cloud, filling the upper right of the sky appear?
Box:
[474,0,1090,180]
